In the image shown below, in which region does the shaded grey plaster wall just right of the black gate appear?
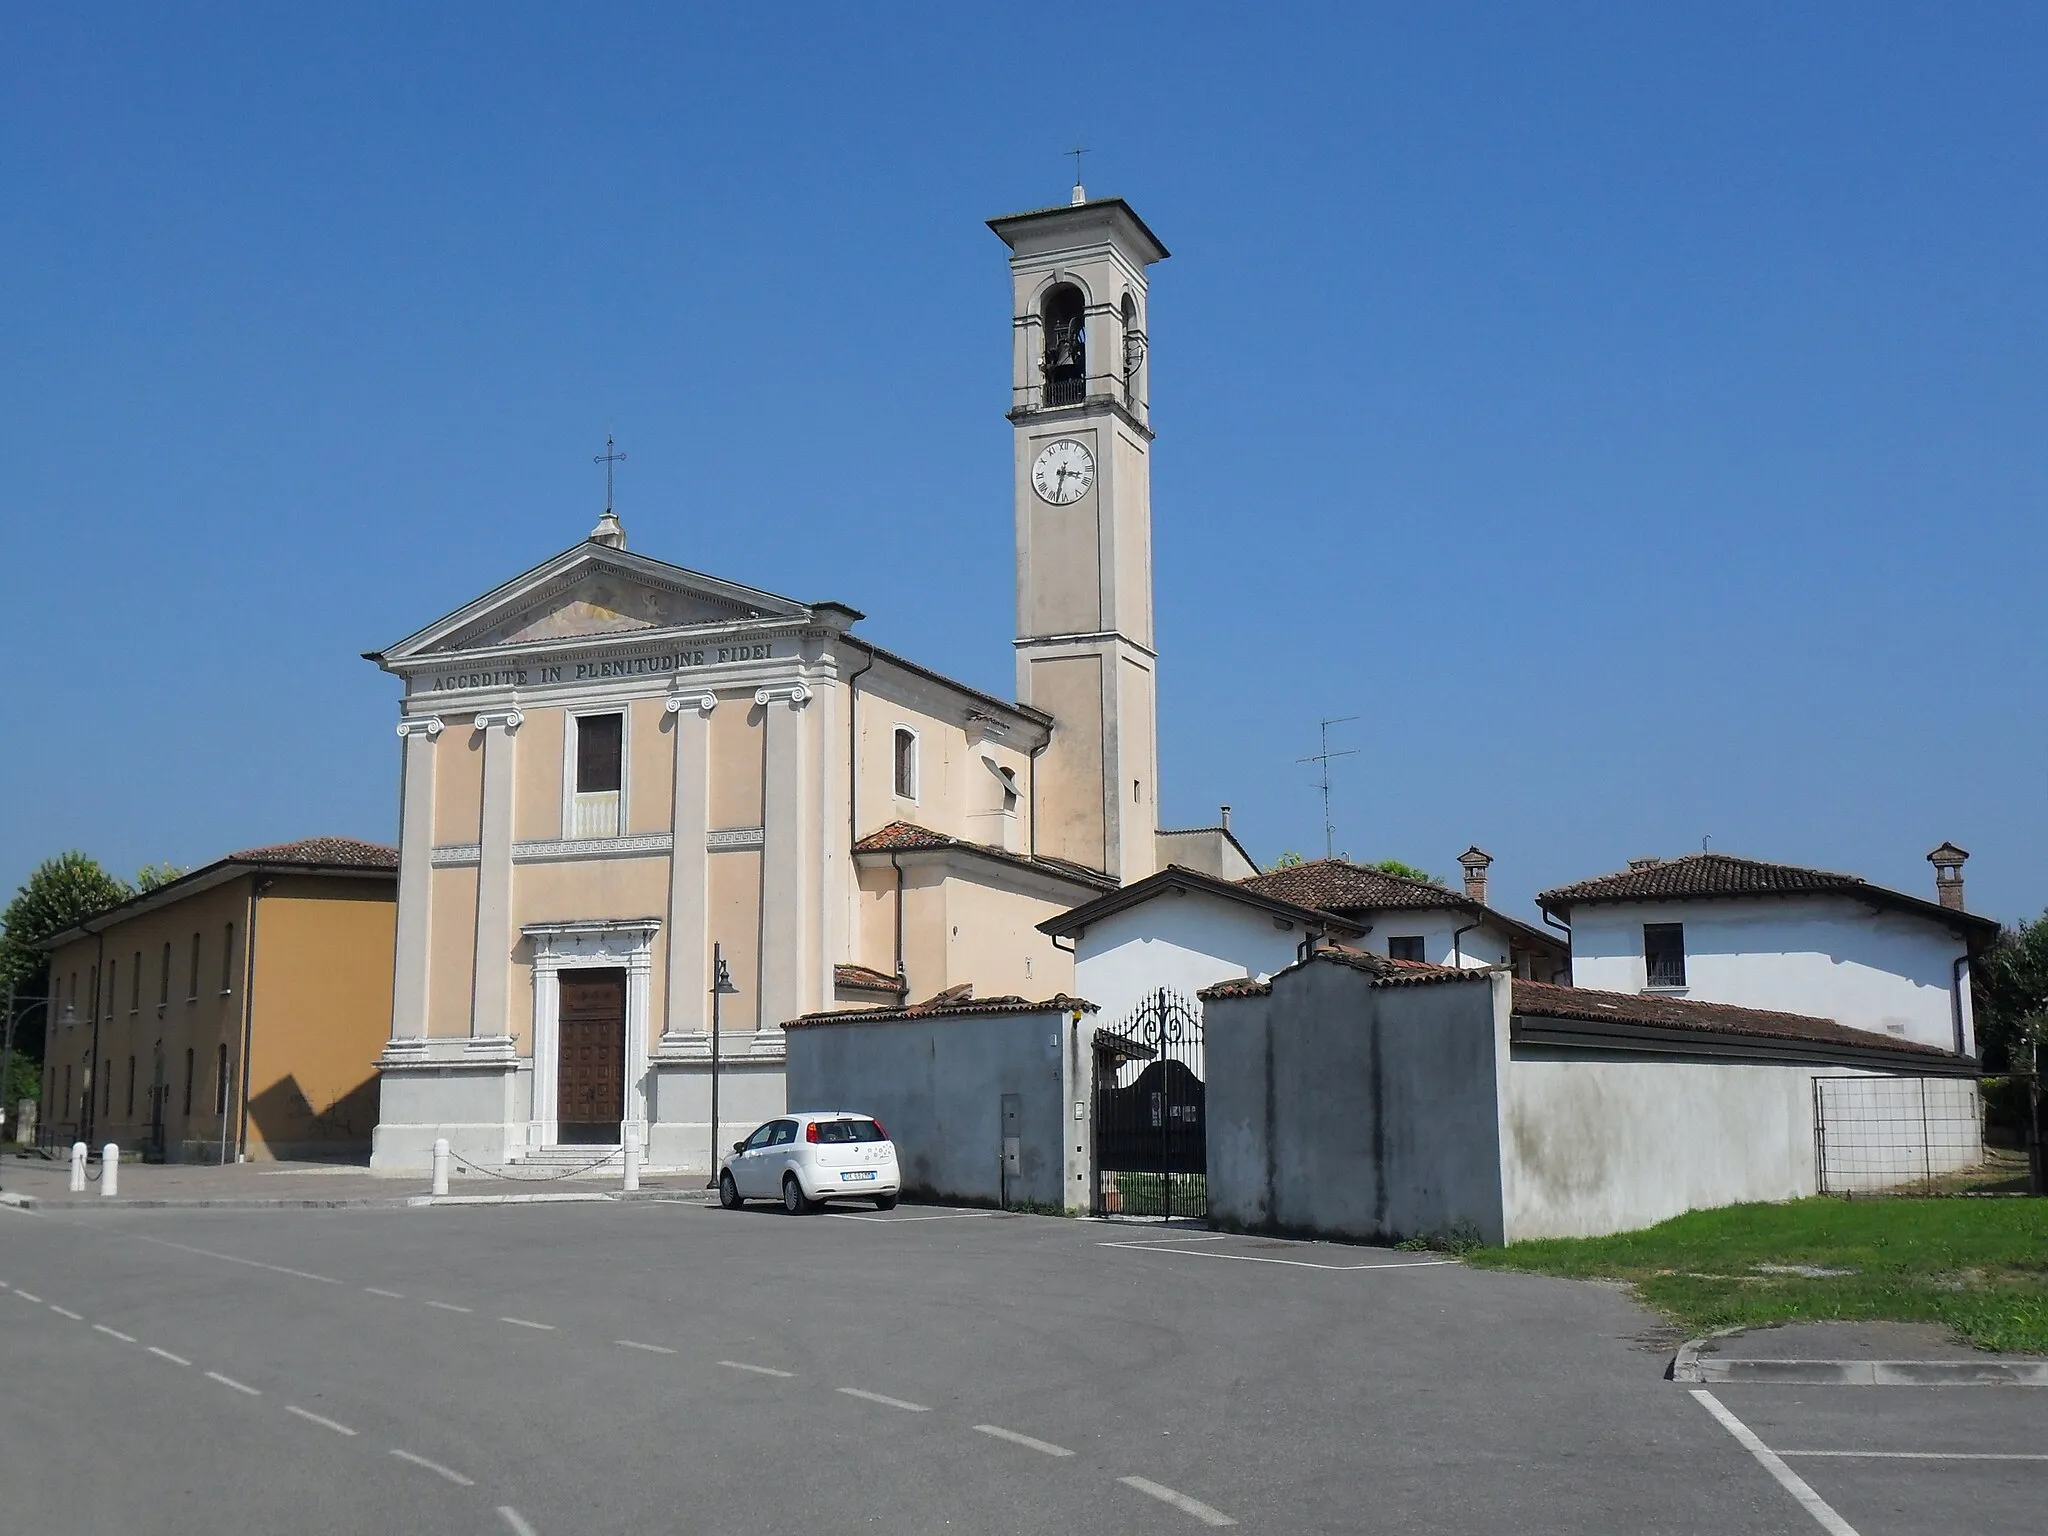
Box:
[1206,963,1507,1243]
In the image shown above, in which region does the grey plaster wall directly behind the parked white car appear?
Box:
[788,1012,1085,1208]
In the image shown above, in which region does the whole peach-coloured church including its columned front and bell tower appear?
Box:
[369,188,1178,1167]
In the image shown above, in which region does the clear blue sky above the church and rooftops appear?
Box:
[0,4,2048,920]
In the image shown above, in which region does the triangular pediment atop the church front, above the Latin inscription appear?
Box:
[381,543,811,662]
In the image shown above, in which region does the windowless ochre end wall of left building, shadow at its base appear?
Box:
[248,877,397,1159]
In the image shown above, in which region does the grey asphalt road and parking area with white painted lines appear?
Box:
[0,1202,2048,1536]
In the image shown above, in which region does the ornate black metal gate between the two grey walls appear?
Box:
[1094,989,1208,1219]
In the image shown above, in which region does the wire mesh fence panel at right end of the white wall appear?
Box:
[1812,1077,1985,1194]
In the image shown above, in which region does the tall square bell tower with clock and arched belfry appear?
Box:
[989,186,1167,883]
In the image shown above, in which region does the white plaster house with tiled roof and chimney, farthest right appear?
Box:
[1536,844,1999,1057]
